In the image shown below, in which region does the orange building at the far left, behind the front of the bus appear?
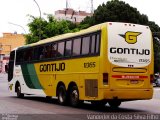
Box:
[0,33,25,72]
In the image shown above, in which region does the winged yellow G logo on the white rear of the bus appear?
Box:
[119,31,141,44]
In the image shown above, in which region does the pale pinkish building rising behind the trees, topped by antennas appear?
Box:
[55,8,92,23]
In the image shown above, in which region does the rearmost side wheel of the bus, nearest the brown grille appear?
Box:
[69,86,81,107]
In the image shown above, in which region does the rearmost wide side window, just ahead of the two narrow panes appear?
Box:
[82,37,90,55]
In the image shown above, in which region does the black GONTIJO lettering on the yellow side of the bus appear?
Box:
[39,62,65,72]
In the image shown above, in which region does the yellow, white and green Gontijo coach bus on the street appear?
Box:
[8,22,154,107]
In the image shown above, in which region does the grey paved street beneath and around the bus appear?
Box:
[0,74,160,120]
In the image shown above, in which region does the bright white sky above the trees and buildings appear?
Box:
[0,0,160,36]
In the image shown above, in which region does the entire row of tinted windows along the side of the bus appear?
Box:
[16,32,100,64]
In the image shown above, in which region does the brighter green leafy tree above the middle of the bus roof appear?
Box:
[25,15,79,44]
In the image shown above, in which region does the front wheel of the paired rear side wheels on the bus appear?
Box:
[58,85,67,105]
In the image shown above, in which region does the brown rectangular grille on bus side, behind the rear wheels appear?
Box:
[85,79,98,97]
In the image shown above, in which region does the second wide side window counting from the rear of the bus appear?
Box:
[73,38,81,56]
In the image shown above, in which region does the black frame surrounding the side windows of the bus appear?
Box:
[16,30,101,65]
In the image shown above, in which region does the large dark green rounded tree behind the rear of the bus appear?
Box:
[81,0,160,31]
